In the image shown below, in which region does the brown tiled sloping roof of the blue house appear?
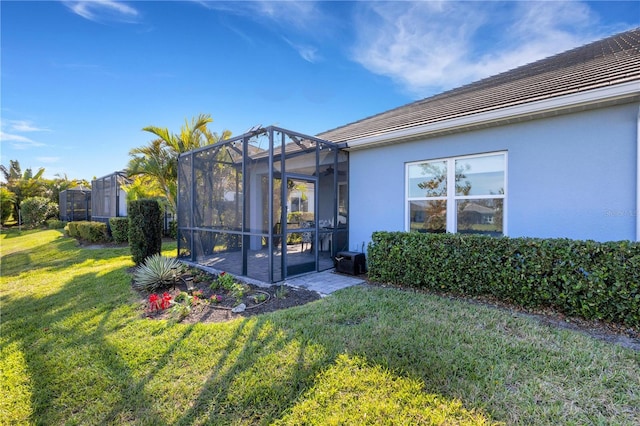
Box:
[318,28,640,142]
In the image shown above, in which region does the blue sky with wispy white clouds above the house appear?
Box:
[0,0,640,180]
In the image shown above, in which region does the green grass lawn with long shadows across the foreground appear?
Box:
[0,230,640,425]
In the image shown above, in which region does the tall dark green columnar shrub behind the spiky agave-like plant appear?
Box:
[128,199,162,265]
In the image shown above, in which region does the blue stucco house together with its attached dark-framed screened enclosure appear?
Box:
[178,25,640,282]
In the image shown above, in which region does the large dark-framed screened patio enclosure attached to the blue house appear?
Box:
[178,127,349,282]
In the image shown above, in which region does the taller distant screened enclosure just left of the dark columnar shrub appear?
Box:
[91,172,129,223]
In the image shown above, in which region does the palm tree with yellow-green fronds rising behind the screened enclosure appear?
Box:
[127,114,231,213]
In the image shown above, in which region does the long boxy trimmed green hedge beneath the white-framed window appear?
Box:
[368,232,640,326]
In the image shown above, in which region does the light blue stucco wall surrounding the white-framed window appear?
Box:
[349,104,639,250]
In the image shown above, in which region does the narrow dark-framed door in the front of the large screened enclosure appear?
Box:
[282,175,318,276]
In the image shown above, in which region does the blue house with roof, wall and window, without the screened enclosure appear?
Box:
[317,29,640,249]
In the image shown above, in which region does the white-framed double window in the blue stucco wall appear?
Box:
[406,152,507,236]
